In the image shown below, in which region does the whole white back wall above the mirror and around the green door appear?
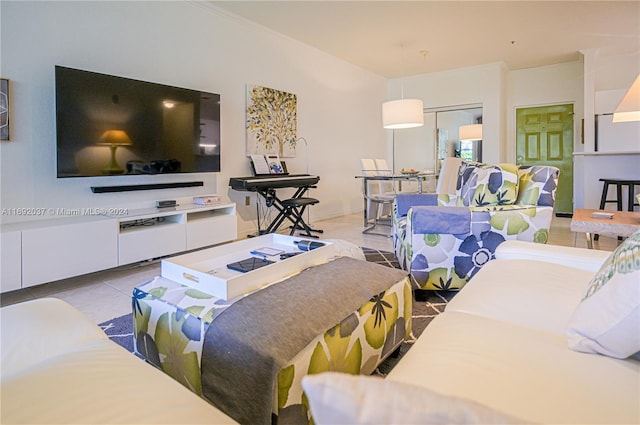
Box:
[387,57,640,212]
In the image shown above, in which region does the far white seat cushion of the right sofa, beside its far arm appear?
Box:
[446,260,593,335]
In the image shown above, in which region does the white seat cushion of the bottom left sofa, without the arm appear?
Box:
[0,338,236,424]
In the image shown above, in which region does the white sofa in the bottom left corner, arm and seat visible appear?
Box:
[0,298,236,424]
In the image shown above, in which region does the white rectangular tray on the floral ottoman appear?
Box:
[161,233,335,300]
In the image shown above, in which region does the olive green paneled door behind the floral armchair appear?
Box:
[516,105,573,215]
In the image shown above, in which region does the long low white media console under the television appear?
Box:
[0,203,238,292]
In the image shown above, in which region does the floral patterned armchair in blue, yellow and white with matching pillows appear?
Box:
[393,161,559,292]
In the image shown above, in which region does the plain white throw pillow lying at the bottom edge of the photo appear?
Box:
[302,372,525,425]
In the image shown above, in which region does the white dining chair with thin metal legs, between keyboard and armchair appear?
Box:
[360,158,395,237]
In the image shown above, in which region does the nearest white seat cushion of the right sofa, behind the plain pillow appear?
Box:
[387,308,640,424]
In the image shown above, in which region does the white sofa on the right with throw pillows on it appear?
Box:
[303,240,640,425]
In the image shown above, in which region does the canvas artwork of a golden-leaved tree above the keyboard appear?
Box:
[246,85,298,158]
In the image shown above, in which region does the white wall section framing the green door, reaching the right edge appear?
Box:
[507,55,640,208]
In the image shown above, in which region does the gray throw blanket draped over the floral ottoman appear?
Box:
[201,257,406,425]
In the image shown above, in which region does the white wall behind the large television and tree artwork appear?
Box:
[0,1,386,233]
